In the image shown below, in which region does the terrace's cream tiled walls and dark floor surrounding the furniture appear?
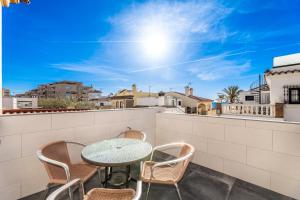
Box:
[0,108,300,200]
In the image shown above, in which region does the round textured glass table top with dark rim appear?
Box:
[81,138,152,166]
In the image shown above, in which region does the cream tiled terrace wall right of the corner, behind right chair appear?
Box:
[156,113,300,199]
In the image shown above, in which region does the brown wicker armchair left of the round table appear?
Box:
[37,141,101,199]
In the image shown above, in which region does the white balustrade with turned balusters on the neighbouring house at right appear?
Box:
[222,104,275,117]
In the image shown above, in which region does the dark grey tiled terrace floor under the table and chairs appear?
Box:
[22,154,292,200]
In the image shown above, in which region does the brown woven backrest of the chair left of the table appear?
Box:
[40,141,71,182]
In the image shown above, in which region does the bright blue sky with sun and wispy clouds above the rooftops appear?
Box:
[3,0,300,98]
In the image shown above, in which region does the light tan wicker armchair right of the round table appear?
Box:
[141,143,195,200]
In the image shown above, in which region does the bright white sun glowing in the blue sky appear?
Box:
[141,26,169,59]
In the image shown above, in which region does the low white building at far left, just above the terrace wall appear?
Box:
[2,97,38,109]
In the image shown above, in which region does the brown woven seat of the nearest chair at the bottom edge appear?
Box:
[84,188,135,200]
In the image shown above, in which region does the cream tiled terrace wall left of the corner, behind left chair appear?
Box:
[0,108,159,200]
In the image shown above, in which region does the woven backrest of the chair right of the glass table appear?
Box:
[176,143,195,182]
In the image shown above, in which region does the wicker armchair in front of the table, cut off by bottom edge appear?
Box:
[47,179,142,200]
